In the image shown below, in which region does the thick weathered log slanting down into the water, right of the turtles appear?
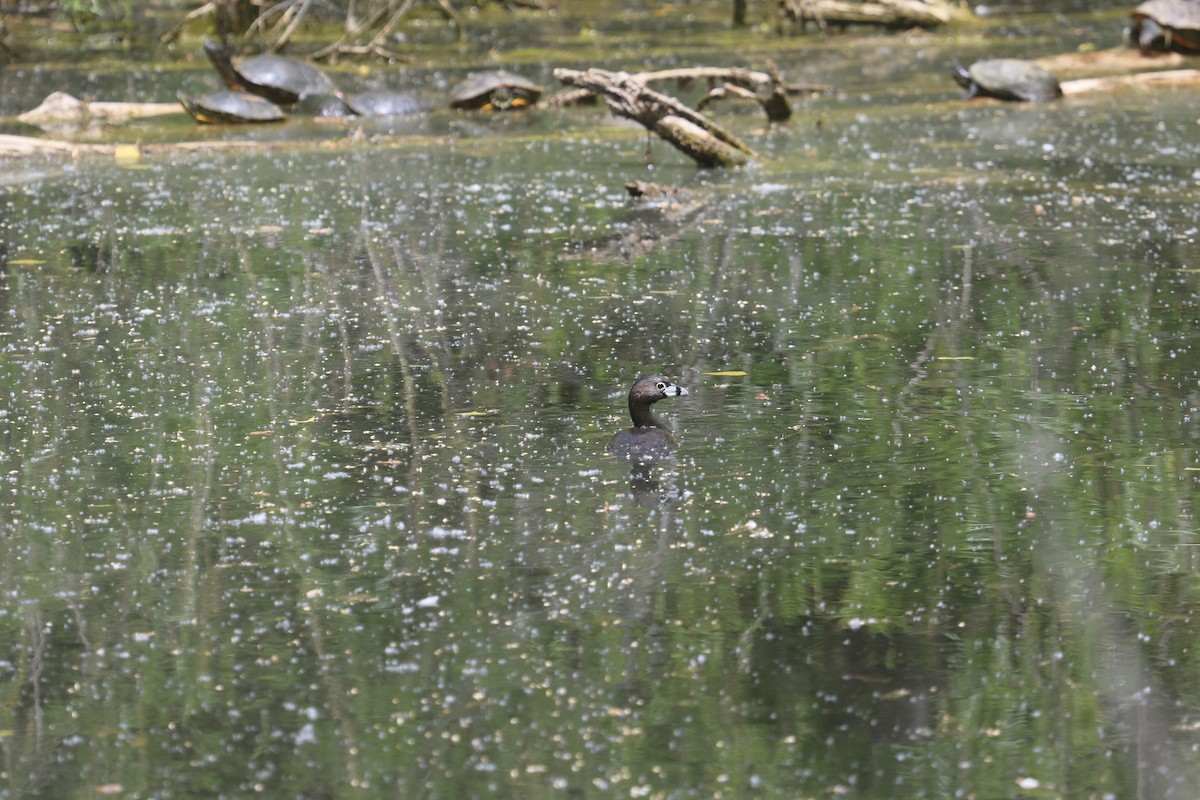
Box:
[554,68,757,167]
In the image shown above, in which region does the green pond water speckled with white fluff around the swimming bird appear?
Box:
[0,4,1200,800]
